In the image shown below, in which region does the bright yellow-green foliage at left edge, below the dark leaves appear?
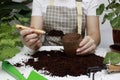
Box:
[0,23,23,60]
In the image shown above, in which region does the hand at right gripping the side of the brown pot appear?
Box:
[76,36,96,55]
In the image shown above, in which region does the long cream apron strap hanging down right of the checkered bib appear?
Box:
[76,0,82,34]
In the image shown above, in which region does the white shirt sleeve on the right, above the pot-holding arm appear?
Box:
[86,0,98,16]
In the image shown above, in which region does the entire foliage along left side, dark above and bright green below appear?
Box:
[0,0,32,60]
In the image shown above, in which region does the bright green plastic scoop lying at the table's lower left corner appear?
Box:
[2,61,48,80]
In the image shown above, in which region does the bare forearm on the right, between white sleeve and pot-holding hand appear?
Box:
[87,16,101,46]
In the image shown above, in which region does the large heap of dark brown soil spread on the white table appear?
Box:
[22,50,104,77]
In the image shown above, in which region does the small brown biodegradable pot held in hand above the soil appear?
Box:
[62,33,82,56]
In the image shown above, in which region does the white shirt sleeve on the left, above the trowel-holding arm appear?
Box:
[32,0,42,16]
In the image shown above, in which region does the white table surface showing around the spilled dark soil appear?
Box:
[0,46,120,80]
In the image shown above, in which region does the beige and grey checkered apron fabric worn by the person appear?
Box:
[43,0,86,46]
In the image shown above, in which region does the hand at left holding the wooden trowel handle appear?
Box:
[20,29,42,51]
